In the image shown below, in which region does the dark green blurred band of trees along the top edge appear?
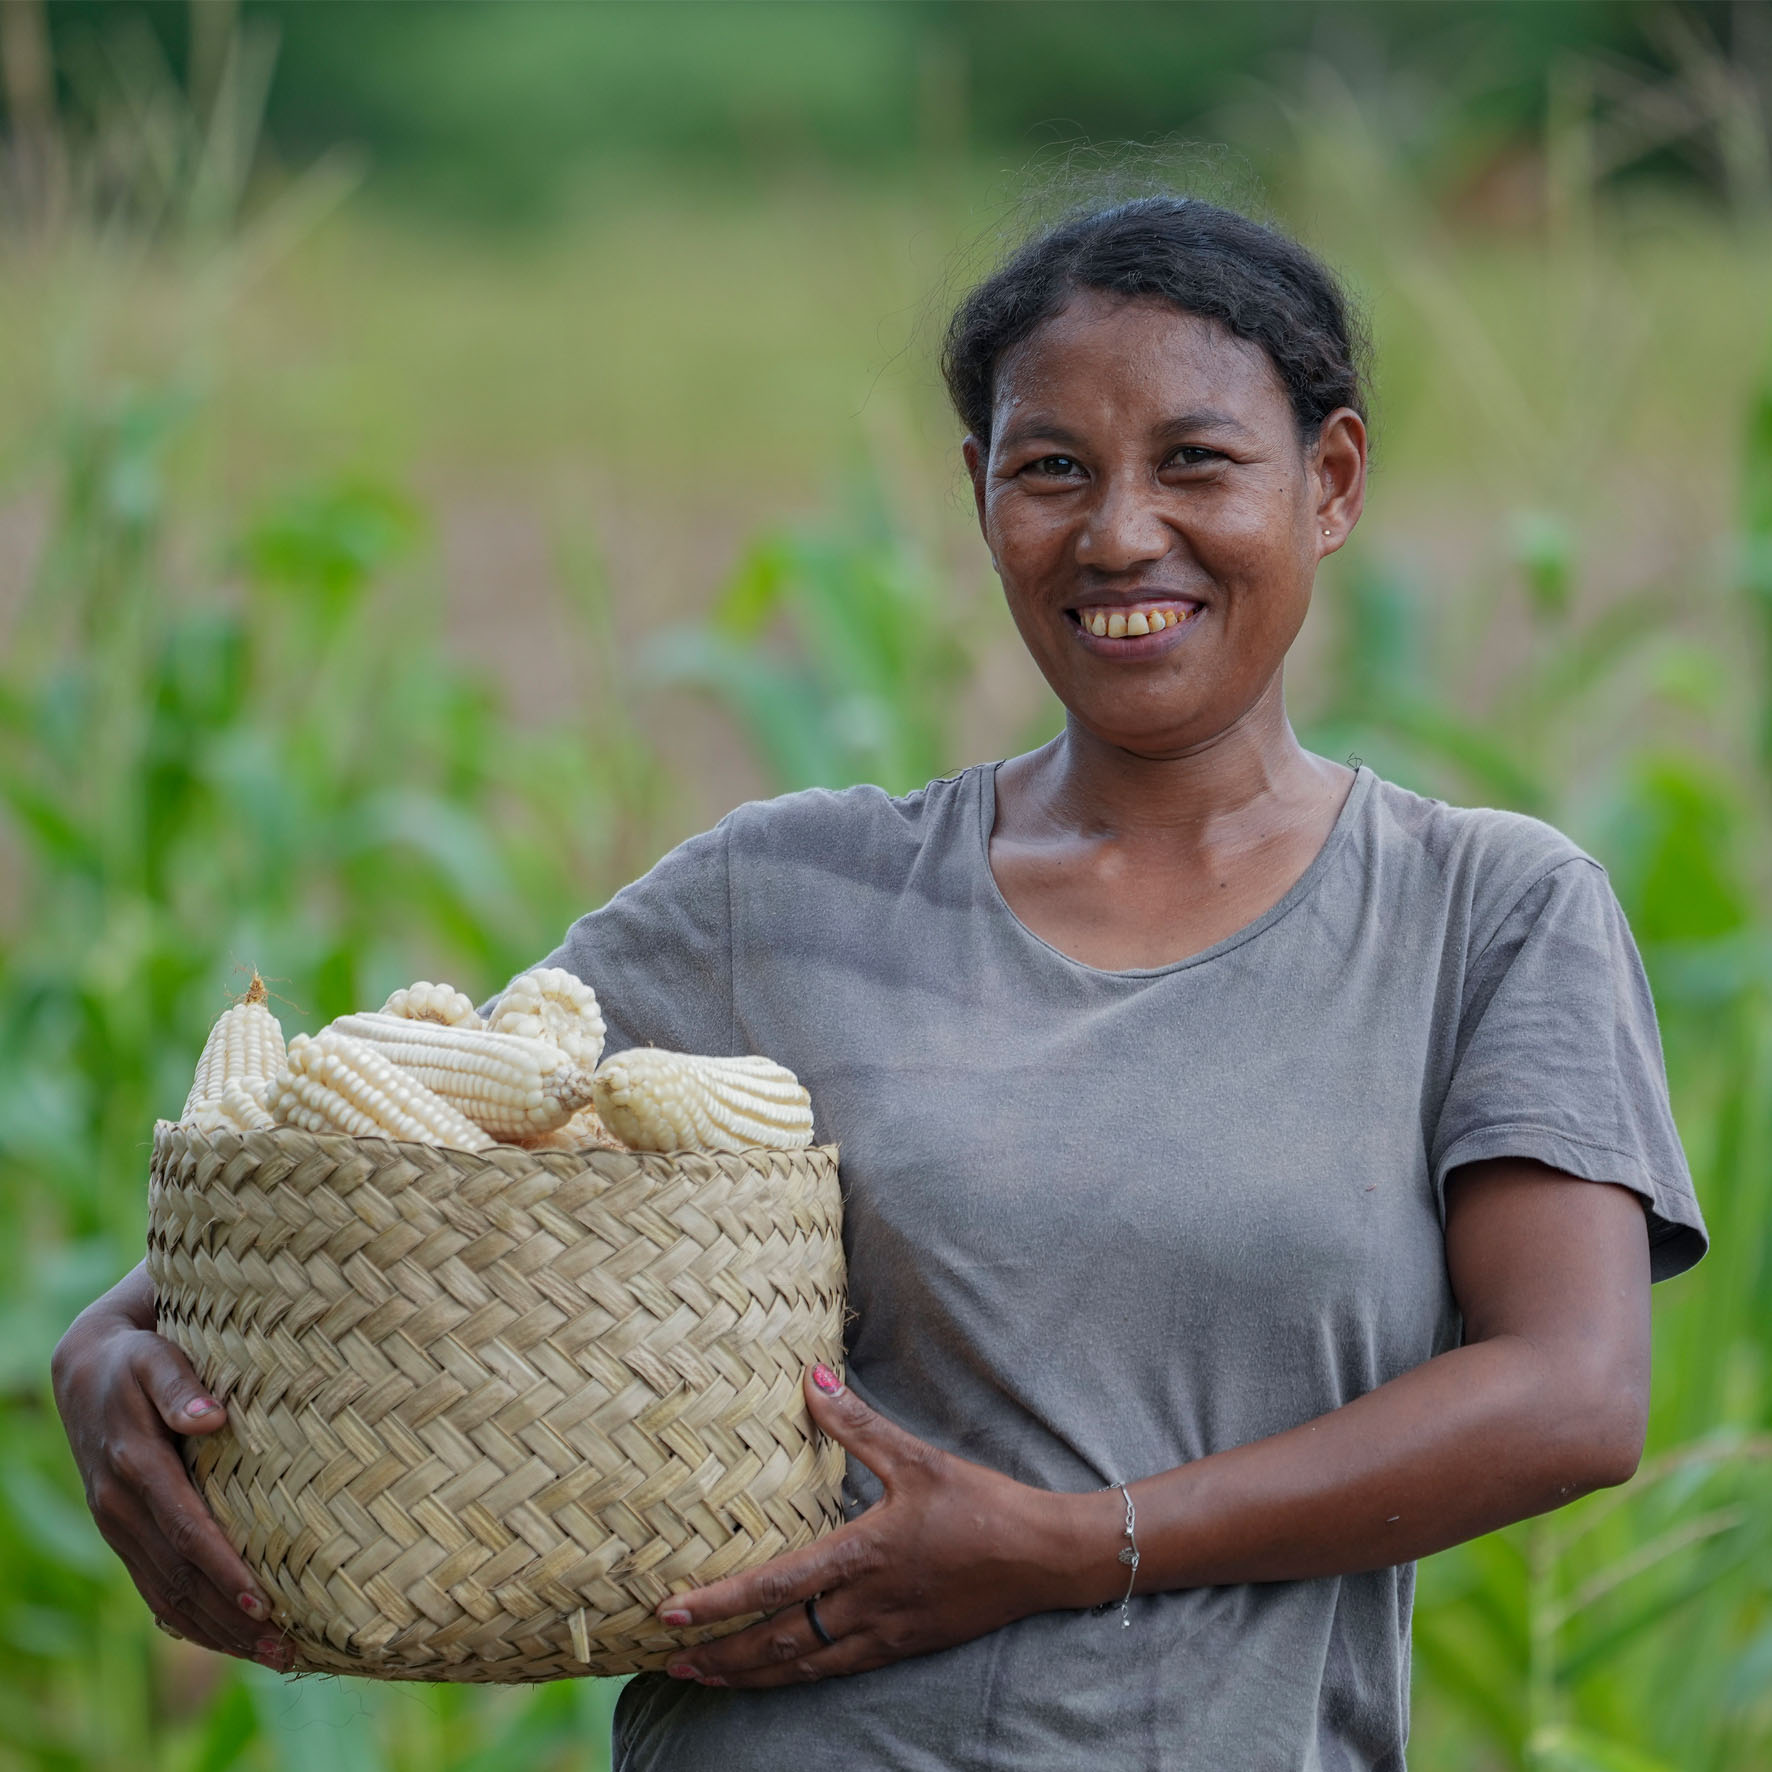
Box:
[38,0,1740,222]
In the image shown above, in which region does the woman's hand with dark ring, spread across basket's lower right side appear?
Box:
[657,1366,1091,1687]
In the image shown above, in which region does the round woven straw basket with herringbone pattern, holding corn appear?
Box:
[147,1122,843,1682]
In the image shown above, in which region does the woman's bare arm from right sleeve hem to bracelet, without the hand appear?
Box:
[1079,1161,1650,1591]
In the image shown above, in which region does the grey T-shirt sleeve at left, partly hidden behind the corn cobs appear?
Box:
[489,820,742,1056]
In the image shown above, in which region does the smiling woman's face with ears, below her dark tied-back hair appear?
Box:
[966,292,1366,757]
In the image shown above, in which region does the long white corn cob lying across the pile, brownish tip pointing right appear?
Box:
[320,1015,590,1139]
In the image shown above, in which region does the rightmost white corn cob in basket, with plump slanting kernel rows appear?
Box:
[595,1045,812,1150]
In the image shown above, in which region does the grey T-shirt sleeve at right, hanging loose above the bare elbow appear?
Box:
[1430,856,1708,1279]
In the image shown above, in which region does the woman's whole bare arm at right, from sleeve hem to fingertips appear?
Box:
[659,1159,1650,1685]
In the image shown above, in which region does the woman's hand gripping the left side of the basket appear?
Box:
[51,1267,292,1673]
